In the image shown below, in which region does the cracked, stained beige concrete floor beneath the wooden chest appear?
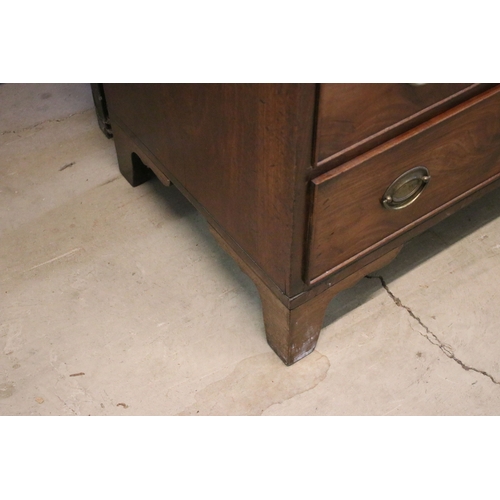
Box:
[0,84,500,415]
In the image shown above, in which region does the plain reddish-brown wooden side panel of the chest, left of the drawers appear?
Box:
[104,84,316,294]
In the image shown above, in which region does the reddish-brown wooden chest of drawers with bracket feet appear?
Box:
[104,84,500,365]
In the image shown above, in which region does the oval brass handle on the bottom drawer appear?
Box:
[382,167,431,210]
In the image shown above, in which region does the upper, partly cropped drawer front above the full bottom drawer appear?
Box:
[317,83,487,162]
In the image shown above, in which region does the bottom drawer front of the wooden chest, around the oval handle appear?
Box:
[306,87,500,283]
